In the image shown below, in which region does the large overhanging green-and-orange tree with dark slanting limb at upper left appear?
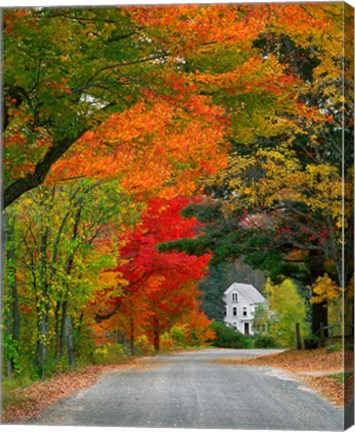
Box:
[4,5,340,207]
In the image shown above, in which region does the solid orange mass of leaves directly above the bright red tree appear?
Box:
[49,96,227,198]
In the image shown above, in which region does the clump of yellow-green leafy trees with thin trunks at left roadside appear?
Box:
[3,180,134,377]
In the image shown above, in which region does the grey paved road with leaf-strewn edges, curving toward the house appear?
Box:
[36,349,343,431]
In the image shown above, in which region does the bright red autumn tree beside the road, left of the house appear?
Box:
[93,197,210,350]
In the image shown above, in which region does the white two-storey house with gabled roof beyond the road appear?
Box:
[224,283,267,335]
